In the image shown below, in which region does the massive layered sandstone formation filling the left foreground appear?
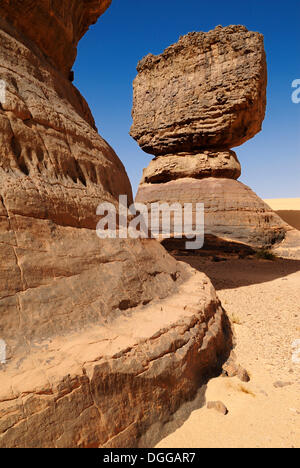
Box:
[0,0,234,447]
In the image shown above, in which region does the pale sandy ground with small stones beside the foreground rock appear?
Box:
[158,256,300,448]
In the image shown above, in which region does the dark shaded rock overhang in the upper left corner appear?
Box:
[0,0,111,77]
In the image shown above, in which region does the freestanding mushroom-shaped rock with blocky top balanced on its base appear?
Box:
[131,26,291,252]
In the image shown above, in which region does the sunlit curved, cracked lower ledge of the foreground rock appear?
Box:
[0,266,230,448]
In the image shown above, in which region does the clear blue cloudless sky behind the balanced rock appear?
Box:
[74,0,300,198]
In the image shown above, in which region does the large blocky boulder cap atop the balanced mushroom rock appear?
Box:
[131,26,267,156]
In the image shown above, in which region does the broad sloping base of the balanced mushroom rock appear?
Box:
[136,177,291,248]
